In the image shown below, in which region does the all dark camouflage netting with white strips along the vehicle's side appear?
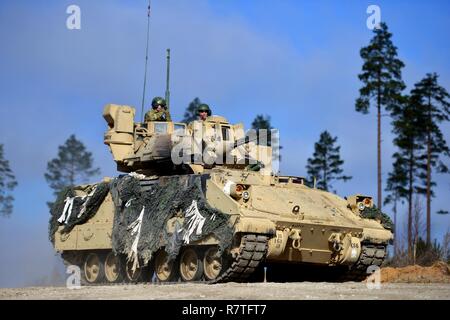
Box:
[49,174,233,265]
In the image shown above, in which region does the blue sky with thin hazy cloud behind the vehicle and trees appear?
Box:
[0,0,450,287]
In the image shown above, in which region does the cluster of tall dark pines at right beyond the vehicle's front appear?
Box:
[355,23,450,258]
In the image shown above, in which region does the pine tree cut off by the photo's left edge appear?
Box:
[0,144,17,217]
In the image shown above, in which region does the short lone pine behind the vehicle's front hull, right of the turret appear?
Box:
[306,131,352,191]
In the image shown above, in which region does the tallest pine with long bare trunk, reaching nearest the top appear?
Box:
[355,22,405,209]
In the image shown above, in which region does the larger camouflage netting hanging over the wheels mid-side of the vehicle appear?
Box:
[111,175,233,264]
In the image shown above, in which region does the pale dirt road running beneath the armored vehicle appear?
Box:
[0,282,450,300]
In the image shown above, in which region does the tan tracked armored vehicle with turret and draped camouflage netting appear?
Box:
[50,105,393,283]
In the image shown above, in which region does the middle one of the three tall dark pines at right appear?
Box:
[387,97,426,258]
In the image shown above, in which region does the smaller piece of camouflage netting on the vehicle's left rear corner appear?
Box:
[49,182,109,243]
